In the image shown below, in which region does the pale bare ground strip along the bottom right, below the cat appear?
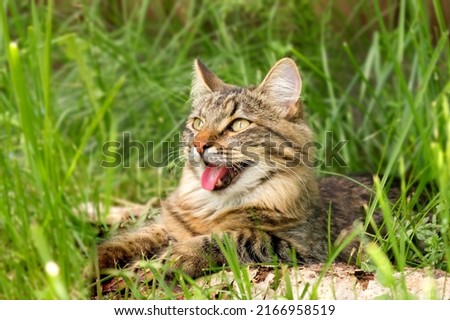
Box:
[200,264,450,300]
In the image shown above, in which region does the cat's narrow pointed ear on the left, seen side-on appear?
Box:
[191,59,229,98]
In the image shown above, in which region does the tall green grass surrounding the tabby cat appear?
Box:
[0,0,450,299]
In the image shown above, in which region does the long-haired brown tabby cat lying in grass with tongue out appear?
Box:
[98,58,371,277]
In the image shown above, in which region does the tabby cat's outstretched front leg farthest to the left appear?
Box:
[97,224,170,270]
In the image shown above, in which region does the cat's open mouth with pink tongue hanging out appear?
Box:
[201,163,249,191]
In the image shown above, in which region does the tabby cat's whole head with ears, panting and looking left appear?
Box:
[184,59,312,193]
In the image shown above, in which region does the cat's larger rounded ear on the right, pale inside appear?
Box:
[256,58,302,117]
